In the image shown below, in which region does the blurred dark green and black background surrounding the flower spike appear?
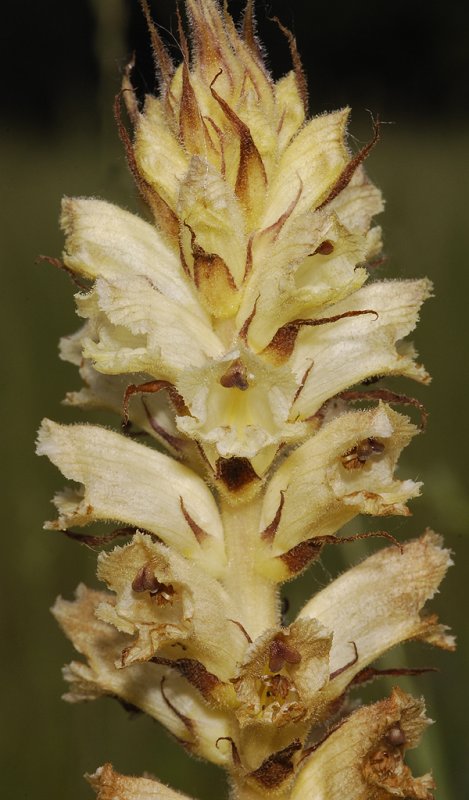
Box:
[0,0,469,800]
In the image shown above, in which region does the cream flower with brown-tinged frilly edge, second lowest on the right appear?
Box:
[298,531,453,697]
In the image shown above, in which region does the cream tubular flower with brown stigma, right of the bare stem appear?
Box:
[259,405,419,569]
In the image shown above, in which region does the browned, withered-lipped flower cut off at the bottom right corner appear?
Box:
[290,689,434,800]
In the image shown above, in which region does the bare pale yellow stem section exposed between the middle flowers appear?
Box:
[221,496,279,640]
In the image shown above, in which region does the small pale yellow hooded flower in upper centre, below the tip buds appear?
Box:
[178,156,246,286]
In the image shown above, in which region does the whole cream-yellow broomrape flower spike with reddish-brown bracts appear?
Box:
[38,0,453,800]
